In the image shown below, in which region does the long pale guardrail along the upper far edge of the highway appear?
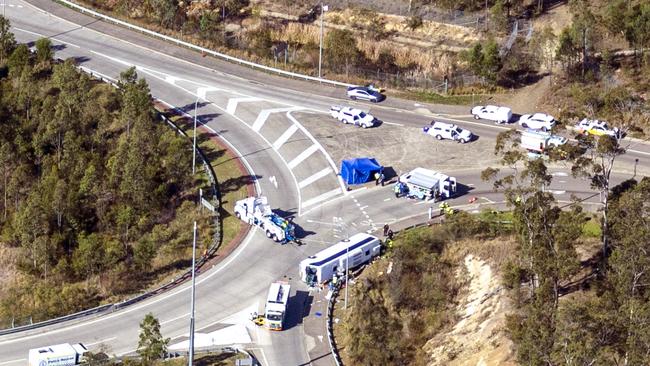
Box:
[57,0,353,87]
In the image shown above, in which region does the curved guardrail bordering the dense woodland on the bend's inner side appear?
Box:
[0,60,223,336]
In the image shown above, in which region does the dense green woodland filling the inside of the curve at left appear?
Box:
[0,24,207,321]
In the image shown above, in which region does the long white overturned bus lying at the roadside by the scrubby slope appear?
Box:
[299,233,381,285]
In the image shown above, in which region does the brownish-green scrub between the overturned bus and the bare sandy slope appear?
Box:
[343,212,509,365]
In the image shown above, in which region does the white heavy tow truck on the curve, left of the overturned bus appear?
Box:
[235,196,296,244]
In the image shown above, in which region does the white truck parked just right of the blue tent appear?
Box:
[395,168,456,200]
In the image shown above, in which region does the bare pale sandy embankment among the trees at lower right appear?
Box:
[425,254,516,366]
